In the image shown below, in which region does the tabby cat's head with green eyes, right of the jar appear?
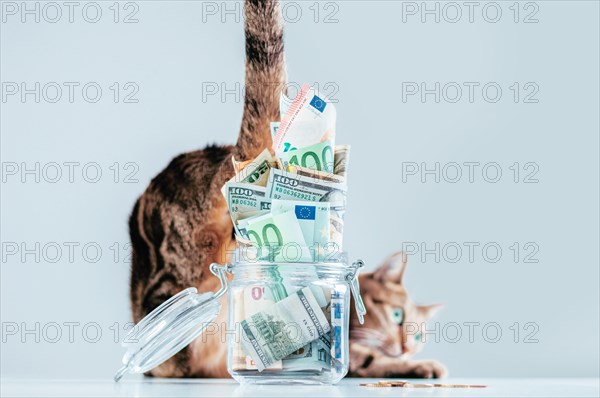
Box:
[350,252,443,359]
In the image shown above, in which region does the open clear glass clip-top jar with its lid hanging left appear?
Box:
[115,250,365,384]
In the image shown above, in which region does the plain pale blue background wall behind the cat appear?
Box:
[0,1,599,378]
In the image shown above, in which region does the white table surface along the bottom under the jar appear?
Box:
[0,377,600,397]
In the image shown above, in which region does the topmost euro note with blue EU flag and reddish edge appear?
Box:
[273,84,336,155]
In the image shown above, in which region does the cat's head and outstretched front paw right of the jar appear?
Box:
[349,252,447,379]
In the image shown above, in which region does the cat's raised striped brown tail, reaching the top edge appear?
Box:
[236,0,287,160]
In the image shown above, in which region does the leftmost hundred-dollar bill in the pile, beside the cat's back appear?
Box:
[223,182,271,236]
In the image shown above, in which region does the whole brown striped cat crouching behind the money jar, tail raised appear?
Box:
[129,0,443,377]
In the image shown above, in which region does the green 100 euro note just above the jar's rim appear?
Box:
[245,211,313,262]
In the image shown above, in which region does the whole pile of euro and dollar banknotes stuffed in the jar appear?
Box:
[222,84,350,372]
